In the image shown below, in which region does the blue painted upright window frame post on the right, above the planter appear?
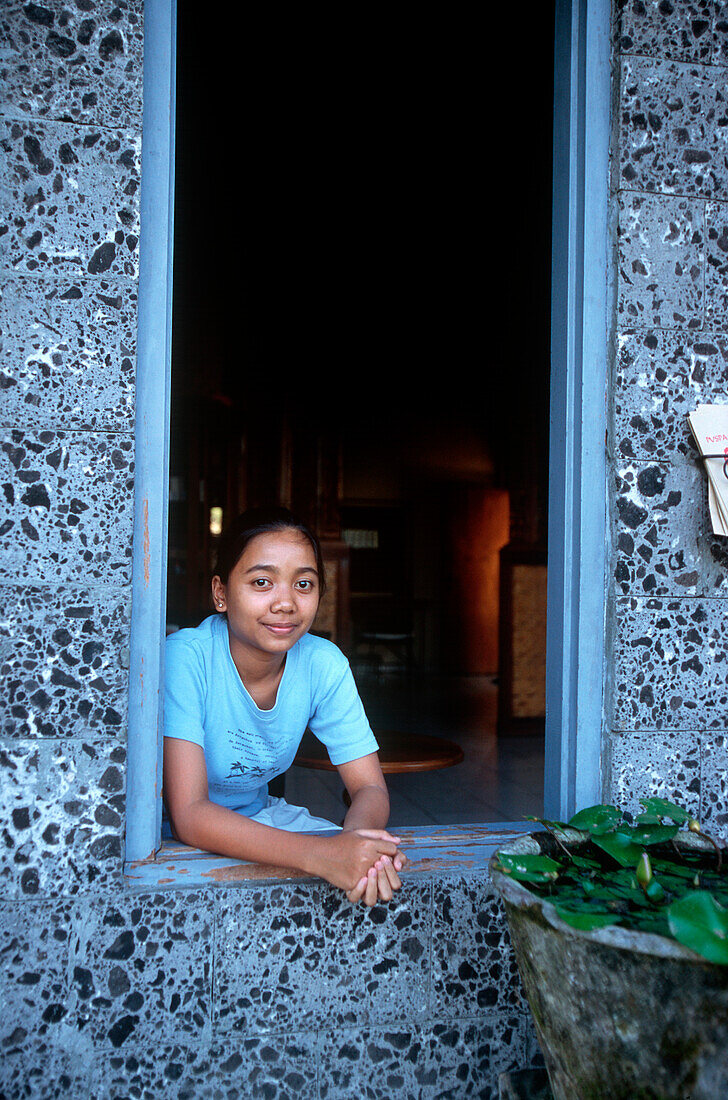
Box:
[544,0,616,820]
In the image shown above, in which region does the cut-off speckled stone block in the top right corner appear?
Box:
[617,0,719,63]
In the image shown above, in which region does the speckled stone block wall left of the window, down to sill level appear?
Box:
[0,0,143,900]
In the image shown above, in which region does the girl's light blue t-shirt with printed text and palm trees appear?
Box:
[164,615,378,816]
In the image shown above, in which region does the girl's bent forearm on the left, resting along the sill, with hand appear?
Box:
[164,737,404,904]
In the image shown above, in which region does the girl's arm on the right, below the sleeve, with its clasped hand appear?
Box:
[337,752,407,905]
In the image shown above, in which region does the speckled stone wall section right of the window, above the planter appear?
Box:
[605,0,728,833]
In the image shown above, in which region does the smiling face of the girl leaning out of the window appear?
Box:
[212,528,320,656]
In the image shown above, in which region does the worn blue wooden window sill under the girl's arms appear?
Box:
[124,822,538,890]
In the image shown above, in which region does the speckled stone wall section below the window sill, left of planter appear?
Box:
[0,871,538,1100]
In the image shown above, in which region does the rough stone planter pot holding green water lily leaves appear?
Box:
[490,833,728,1100]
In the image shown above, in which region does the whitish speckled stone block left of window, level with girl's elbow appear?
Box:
[0,738,125,899]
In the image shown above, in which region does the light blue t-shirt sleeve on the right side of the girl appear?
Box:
[309,650,379,765]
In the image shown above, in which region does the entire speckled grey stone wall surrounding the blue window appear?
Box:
[12,0,728,1100]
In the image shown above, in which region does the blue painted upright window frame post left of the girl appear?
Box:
[126,0,177,860]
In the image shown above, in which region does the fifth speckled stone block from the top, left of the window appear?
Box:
[0,585,131,738]
